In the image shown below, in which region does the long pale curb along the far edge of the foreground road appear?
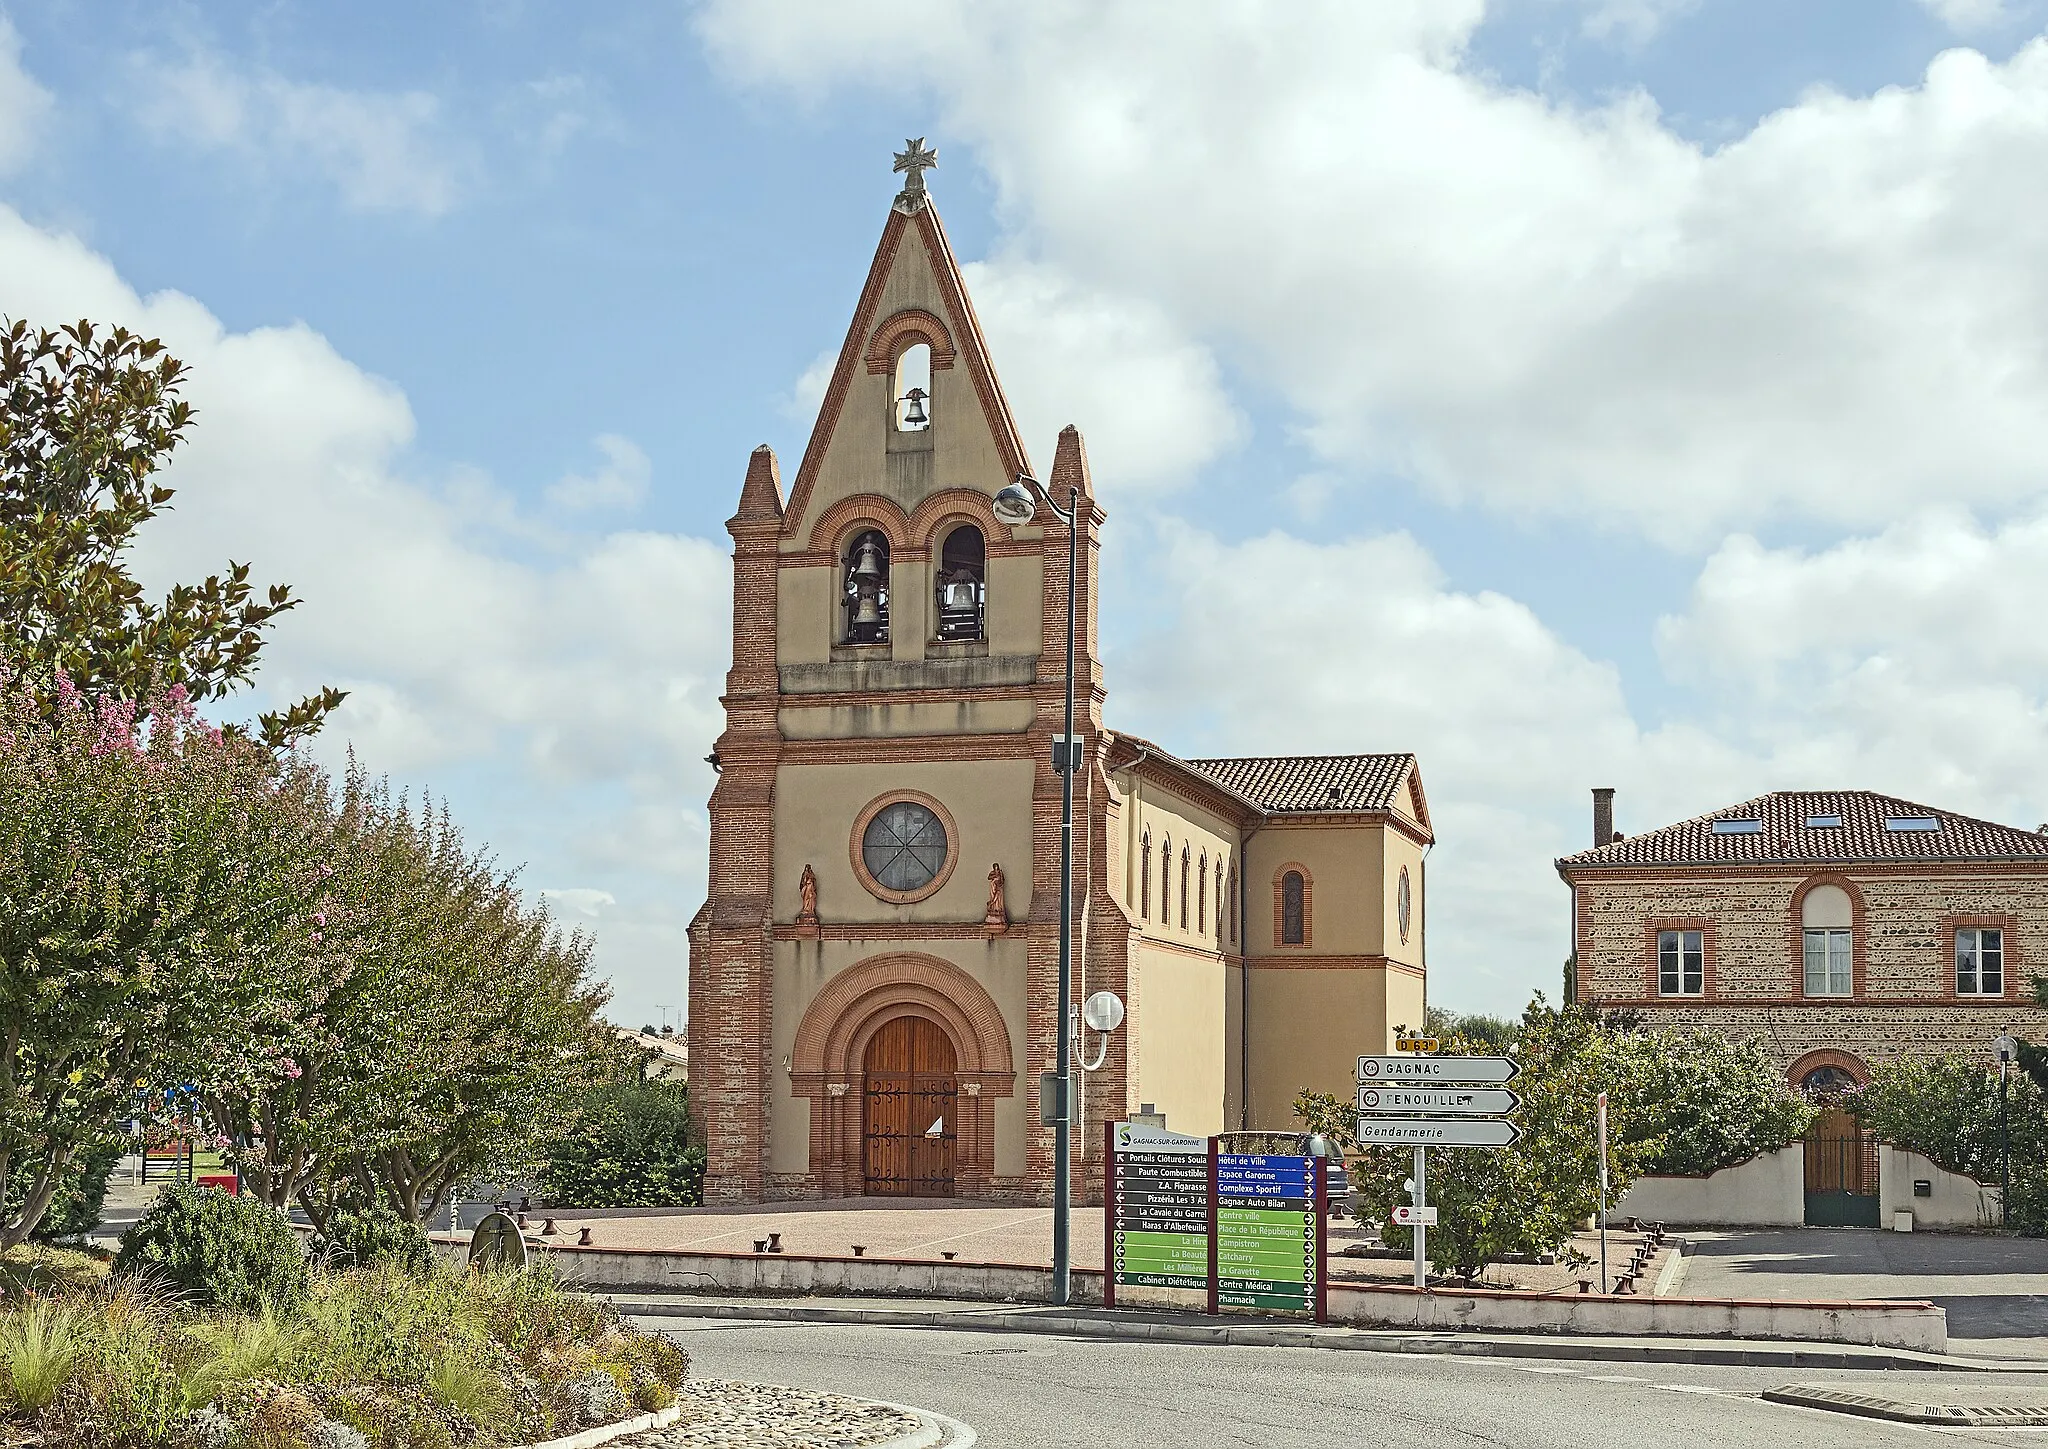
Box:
[610,1298,1990,1373]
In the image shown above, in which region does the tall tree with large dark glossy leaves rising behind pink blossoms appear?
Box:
[0,321,346,745]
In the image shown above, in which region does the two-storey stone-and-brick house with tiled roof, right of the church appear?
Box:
[1556,790,2048,1087]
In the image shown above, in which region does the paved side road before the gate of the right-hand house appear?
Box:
[1679,1228,2048,1359]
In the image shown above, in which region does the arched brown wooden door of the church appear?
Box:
[860,1017,956,1197]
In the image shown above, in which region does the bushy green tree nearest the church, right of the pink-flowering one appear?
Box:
[205,770,610,1224]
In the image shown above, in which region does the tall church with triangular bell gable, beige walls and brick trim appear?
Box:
[688,147,1432,1201]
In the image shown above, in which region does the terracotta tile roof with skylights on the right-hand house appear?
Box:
[1556,790,2048,870]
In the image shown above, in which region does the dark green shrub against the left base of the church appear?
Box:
[541,1081,705,1208]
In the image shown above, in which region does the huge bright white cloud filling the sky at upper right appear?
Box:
[700,0,2048,546]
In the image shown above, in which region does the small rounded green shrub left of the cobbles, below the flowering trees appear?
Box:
[115,1183,307,1312]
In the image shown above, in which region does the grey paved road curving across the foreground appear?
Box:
[641,1318,2048,1449]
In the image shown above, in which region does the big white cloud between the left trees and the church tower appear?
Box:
[0,207,737,1023]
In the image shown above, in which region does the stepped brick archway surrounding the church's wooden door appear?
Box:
[788,954,1016,1197]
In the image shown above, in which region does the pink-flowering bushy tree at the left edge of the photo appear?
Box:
[0,671,322,1248]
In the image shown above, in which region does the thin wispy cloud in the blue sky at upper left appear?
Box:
[129,51,467,217]
